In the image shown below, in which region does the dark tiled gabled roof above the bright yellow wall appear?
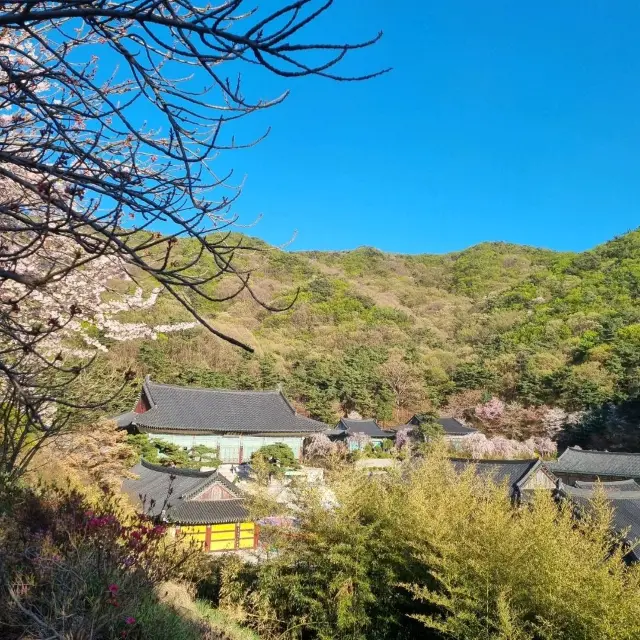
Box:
[122,460,249,524]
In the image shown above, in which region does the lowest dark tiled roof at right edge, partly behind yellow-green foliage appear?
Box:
[563,480,640,561]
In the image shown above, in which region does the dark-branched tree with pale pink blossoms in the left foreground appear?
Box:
[0,0,380,475]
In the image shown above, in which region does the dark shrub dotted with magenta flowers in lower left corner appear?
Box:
[0,487,201,640]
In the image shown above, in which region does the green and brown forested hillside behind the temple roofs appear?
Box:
[95,230,640,444]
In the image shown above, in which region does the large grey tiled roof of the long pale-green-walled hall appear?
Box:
[134,378,327,434]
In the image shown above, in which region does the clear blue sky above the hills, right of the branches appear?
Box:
[151,0,640,253]
